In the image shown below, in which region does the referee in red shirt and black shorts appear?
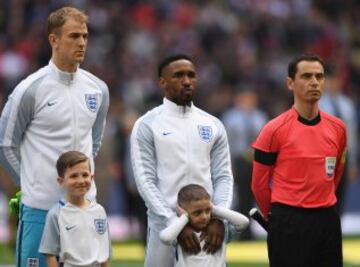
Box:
[251,54,346,267]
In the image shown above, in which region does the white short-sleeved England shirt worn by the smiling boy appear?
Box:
[39,201,111,267]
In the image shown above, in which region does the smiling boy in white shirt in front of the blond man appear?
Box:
[39,151,111,267]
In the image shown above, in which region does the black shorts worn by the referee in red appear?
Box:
[267,203,343,267]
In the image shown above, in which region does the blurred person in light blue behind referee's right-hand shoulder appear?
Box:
[320,68,358,215]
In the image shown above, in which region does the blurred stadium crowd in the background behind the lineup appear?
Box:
[0,0,360,242]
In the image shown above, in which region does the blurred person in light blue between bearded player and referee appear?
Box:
[222,88,267,240]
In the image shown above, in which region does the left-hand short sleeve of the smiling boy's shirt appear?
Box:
[39,205,60,255]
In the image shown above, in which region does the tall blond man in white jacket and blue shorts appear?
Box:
[0,7,109,267]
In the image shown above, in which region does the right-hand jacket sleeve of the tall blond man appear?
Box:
[92,82,110,157]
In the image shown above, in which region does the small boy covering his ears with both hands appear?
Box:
[160,184,249,267]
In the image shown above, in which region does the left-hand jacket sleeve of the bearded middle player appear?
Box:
[130,118,176,224]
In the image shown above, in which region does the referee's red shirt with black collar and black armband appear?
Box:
[252,108,346,217]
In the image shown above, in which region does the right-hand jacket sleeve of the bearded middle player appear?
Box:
[210,121,234,208]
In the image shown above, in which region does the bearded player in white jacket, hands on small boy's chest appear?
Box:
[131,54,233,267]
